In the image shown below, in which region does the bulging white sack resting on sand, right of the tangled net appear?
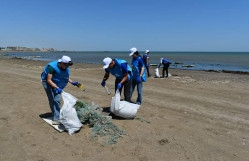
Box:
[110,89,140,119]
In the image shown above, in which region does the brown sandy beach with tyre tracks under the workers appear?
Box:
[0,58,249,161]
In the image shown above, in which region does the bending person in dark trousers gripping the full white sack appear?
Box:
[101,57,132,102]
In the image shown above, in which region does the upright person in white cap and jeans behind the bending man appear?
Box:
[130,48,146,105]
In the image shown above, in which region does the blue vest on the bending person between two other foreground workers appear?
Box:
[109,59,132,81]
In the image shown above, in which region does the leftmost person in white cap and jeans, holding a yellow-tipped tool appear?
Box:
[41,56,78,125]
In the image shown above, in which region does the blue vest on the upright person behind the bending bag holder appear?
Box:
[131,56,146,82]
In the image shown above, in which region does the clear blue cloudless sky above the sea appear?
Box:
[0,0,249,52]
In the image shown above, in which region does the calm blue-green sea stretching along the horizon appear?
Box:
[0,51,249,72]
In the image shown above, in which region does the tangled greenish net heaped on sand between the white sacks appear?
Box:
[74,100,126,145]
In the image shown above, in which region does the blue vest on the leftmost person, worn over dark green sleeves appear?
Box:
[41,61,70,89]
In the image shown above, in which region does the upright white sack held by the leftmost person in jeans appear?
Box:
[59,91,83,135]
